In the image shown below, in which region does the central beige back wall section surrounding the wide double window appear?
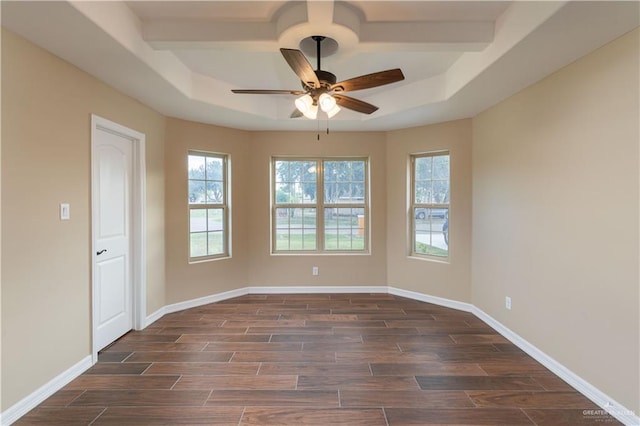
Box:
[248,132,387,286]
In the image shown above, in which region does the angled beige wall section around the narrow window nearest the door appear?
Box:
[165,118,251,304]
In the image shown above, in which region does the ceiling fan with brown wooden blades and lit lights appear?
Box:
[232,36,404,119]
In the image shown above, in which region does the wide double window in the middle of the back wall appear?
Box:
[272,158,369,253]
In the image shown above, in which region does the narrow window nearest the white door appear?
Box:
[188,151,229,261]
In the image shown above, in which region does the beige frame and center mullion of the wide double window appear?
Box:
[270,155,371,256]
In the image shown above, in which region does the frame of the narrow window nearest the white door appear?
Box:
[187,149,231,263]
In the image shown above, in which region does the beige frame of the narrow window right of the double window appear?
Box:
[408,150,452,262]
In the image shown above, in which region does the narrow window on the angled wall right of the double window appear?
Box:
[410,152,450,257]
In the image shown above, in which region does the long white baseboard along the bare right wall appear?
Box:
[471,306,640,426]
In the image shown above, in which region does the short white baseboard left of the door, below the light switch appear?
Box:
[0,355,93,425]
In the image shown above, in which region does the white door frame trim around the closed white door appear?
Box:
[91,114,147,364]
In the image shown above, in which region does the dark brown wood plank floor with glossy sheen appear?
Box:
[17,294,620,426]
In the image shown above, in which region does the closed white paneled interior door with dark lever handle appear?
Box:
[92,127,134,351]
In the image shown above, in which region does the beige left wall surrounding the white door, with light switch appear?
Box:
[1,29,165,410]
